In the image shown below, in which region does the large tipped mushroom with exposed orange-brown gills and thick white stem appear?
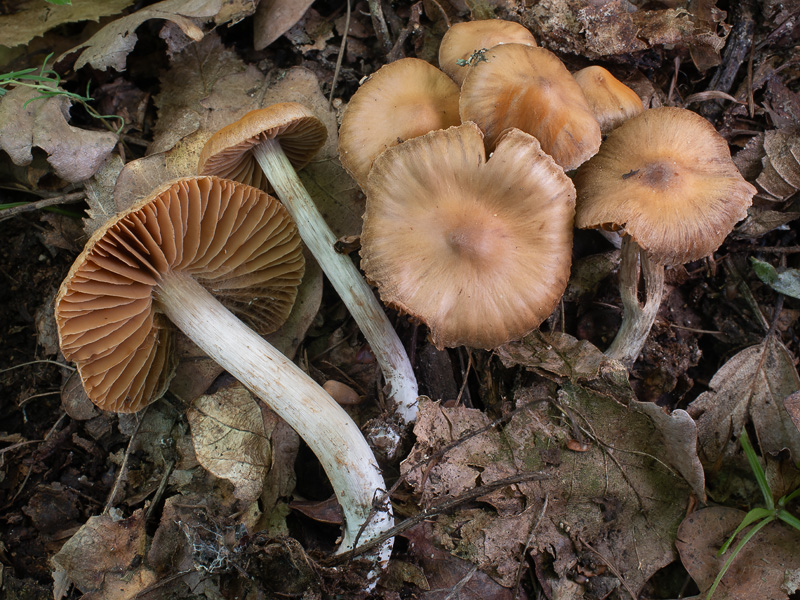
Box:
[55,177,393,563]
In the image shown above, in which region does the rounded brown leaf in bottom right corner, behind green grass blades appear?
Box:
[676,506,800,600]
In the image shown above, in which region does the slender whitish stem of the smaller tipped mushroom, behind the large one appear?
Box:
[253,139,418,424]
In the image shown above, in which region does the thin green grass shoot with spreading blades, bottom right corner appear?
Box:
[706,429,800,600]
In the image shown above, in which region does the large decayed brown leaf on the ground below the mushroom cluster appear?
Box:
[402,332,690,592]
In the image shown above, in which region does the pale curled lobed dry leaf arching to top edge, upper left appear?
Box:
[58,0,222,71]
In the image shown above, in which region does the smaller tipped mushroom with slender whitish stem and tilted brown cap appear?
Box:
[198,103,417,425]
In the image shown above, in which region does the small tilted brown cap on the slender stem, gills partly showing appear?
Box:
[197,102,328,190]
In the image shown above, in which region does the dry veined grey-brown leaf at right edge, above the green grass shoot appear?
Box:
[688,336,800,464]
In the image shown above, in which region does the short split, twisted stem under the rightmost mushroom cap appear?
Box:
[606,235,664,367]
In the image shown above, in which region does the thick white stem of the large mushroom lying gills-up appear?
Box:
[156,273,393,567]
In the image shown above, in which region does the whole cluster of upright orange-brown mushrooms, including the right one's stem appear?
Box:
[339,19,753,364]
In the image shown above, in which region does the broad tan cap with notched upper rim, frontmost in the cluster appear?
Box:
[361,123,575,348]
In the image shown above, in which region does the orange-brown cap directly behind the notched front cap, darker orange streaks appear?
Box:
[459,44,601,171]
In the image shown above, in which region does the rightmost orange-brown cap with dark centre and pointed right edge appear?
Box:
[575,107,756,265]
